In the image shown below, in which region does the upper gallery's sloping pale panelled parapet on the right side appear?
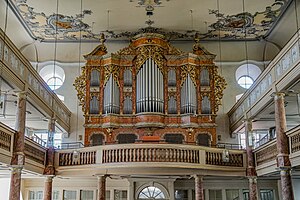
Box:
[228,29,300,131]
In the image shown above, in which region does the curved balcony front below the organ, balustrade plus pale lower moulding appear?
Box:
[55,144,246,176]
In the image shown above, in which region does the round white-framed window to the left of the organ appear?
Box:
[40,65,65,90]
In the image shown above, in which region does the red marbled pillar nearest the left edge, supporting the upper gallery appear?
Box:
[9,92,26,200]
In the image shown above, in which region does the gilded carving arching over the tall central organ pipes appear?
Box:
[136,45,166,74]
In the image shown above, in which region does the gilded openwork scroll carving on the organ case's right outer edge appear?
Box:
[214,67,227,113]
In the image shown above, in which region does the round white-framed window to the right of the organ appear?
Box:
[235,63,261,89]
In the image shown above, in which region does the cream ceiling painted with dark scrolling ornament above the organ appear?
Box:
[9,0,291,42]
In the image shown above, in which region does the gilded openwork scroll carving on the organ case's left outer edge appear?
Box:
[73,66,86,113]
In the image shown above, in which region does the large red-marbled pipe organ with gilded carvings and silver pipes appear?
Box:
[74,33,226,145]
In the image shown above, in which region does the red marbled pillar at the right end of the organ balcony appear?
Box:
[245,120,258,200]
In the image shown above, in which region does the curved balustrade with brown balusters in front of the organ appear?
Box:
[56,144,246,170]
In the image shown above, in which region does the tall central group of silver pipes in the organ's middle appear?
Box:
[136,59,164,113]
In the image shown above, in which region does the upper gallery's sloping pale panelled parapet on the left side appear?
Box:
[0,29,71,132]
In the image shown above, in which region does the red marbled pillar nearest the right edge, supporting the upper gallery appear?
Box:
[274,93,294,200]
